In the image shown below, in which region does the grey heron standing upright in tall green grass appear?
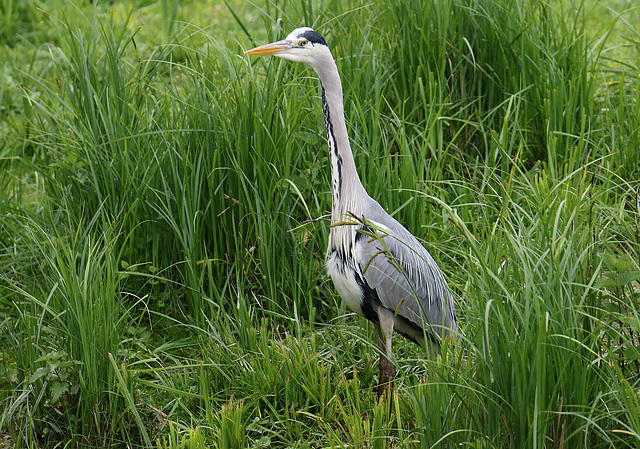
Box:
[245,27,458,397]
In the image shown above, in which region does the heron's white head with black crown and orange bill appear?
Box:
[244,27,332,71]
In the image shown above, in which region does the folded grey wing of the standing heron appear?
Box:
[354,213,457,340]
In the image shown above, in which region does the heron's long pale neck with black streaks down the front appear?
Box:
[314,50,368,224]
